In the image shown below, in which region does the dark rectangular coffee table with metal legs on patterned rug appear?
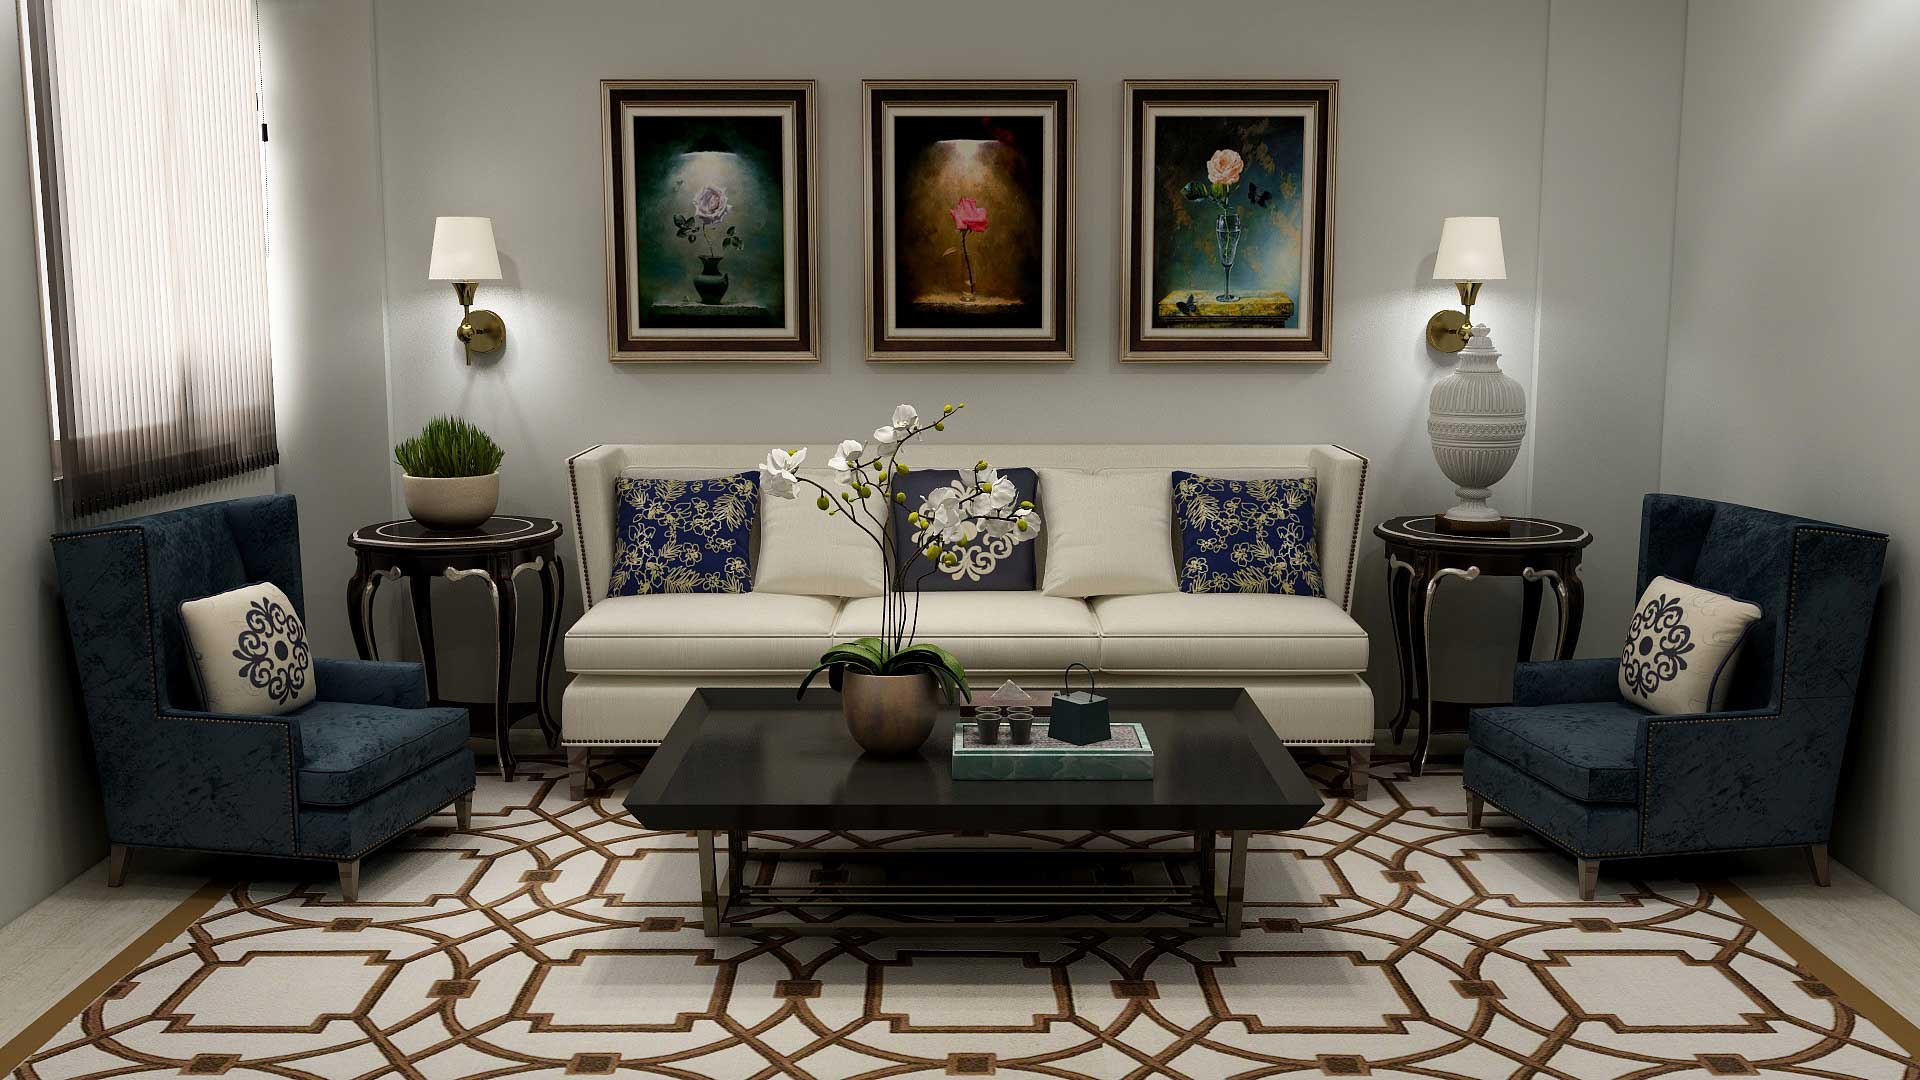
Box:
[626,688,1321,936]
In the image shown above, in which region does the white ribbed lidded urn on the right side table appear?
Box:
[1427,325,1526,523]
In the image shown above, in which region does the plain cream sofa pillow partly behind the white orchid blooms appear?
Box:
[753,469,887,596]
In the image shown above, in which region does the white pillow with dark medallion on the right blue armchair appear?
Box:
[1620,577,1761,717]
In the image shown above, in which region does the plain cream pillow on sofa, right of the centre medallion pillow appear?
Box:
[1041,469,1179,598]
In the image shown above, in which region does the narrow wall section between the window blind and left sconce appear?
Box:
[259,0,392,655]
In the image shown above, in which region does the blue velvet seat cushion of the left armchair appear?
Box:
[292,701,470,807]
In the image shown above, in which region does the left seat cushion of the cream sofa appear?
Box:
[566,592,844,673]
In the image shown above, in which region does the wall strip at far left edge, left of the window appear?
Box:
[0,8,106,922]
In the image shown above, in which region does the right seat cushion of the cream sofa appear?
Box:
[1092,592,1367,673]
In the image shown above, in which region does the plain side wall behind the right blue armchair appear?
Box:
[1661,0,1920,907]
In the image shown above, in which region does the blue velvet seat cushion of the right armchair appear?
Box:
[1467,701,1647,803]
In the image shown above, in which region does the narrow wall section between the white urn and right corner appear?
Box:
[1528,0,1686,655]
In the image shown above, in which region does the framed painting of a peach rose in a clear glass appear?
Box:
[1119,79,1340,361]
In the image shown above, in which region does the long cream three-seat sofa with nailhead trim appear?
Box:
[561,440,1373,794]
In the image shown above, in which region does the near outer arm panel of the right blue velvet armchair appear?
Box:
[1640,703,1847,851]
